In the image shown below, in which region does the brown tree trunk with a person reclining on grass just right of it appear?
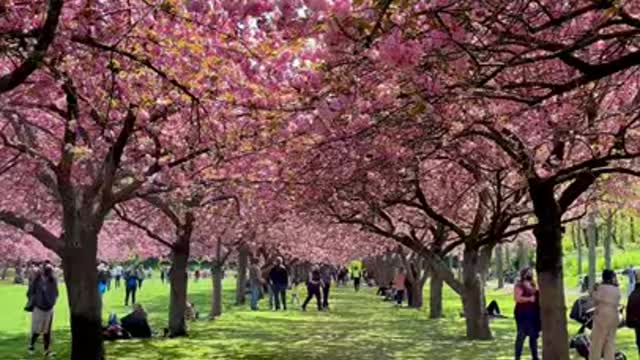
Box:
[462,248,492,340]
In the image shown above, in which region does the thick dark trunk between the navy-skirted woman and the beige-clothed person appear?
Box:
[529,182,569,360]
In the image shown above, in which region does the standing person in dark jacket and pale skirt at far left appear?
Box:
[26,265,58,357]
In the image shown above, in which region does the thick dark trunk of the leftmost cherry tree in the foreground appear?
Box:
[62,224,104,360]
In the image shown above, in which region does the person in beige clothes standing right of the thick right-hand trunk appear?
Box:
[589,269,621,360]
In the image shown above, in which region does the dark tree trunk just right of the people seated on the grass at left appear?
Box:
[169,239,189,337]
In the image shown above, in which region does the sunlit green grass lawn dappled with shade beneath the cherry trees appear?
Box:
[0,279,635,360]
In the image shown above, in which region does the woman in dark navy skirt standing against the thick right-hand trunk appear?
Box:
[513,268,540,360]
